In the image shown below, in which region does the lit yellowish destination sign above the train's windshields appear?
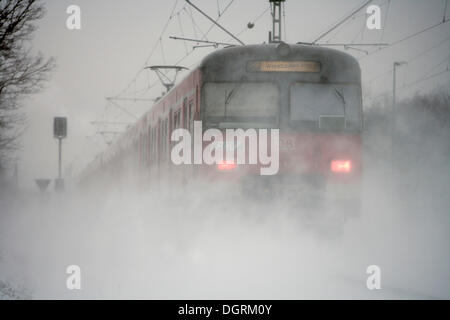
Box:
[247,61,320,72]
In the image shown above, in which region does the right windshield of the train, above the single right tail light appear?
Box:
[290,83,361,130]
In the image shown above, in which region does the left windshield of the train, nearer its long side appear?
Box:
[204,82,279,129]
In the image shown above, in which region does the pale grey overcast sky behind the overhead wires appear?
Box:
[14,0,450,188]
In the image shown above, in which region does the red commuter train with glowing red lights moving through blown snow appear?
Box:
[81,42,363,210]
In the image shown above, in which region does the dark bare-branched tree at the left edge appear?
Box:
[0,0,55,170]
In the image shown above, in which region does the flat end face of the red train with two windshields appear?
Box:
[200,43,362,213]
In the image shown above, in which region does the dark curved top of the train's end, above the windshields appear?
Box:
[199,42,361,83]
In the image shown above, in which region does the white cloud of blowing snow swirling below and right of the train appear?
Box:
[0,92,450,299]
